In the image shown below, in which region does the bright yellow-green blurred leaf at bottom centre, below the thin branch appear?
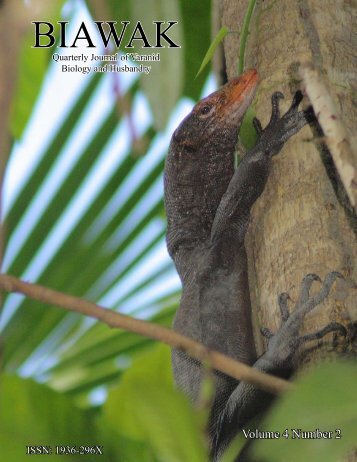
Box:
[104,345,208,462]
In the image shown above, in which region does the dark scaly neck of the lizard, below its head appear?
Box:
[164,129,238,259]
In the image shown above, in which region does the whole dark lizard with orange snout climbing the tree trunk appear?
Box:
[165,70,336,458]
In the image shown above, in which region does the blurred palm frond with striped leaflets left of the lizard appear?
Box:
[2,0,210,402]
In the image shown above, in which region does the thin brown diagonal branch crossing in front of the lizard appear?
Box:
[0,274,292,394]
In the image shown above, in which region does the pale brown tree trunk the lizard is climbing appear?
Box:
[220,0,357,362]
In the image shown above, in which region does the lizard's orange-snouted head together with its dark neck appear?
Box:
[164,70,258,256]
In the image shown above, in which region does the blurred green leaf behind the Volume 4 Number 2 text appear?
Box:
[252,362,357,462]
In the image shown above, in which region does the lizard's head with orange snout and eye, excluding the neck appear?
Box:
[173,69,258,151]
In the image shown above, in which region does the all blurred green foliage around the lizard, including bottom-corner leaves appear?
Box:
[0,0,357,462]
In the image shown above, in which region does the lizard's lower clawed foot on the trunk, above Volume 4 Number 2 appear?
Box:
[261,271,347,370]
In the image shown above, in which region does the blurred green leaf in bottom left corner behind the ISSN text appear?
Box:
[0,375,104,462]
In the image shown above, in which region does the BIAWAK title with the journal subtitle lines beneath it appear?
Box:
[32,21,181,74]
